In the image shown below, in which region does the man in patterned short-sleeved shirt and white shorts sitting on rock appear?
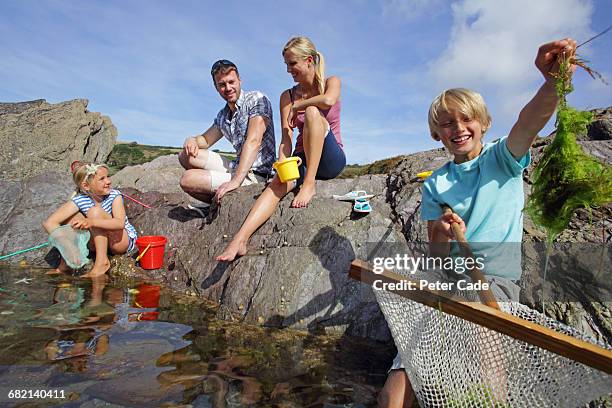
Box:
[179,60,276,203]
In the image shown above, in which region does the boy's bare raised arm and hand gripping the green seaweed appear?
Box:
[507,38,576,159]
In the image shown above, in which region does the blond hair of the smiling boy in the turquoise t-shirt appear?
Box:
[427,88,491,139]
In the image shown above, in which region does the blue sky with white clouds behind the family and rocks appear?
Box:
[0,0,612,163]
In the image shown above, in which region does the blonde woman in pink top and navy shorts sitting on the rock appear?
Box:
[217,37,346,261]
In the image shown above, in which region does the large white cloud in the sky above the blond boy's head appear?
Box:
[430,0,593,92]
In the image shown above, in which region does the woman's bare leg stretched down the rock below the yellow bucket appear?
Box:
[217,176,293,262]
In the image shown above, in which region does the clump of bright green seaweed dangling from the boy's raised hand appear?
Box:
[525,53,612,242]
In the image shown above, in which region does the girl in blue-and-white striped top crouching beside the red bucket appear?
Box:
[43,162,136,277]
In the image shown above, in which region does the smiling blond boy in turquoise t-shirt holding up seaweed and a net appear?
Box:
[379,38,576,407]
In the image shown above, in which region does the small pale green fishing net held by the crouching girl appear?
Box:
[48,225,91,269]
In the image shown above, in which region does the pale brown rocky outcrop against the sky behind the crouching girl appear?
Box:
[0,99,117,180]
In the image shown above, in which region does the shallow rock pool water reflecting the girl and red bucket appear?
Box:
[0,268,393,408]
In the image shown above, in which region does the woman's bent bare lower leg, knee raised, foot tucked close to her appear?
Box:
[291,106,329,208]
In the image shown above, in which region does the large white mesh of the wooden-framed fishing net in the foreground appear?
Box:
[374,275,612,407]
